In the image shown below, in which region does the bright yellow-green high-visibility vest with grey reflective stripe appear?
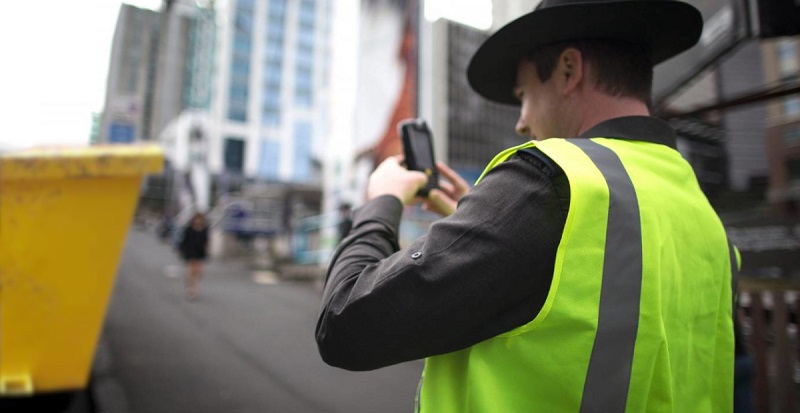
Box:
[417,138,736,413]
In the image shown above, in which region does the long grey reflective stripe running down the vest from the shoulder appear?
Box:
[568,139,642,413]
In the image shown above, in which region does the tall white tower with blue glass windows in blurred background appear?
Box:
[208,0,332,184]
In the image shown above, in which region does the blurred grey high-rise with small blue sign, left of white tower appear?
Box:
[99,0,215,143]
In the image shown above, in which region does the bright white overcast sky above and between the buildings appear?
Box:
[0,0,491,149]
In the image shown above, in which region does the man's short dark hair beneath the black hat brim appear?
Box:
[525,39,653,107]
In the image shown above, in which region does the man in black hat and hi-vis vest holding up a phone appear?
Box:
[316,0,736,413]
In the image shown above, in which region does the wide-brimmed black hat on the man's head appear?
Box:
[467,0,703,105]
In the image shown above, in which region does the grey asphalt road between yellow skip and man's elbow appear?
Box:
[93,230,422,413]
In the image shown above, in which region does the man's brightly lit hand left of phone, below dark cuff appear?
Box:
[367,156,428,205]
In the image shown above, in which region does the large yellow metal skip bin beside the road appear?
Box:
[0,146,163,397]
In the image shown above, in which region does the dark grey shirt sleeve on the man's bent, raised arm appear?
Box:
[316,152,568,370]
